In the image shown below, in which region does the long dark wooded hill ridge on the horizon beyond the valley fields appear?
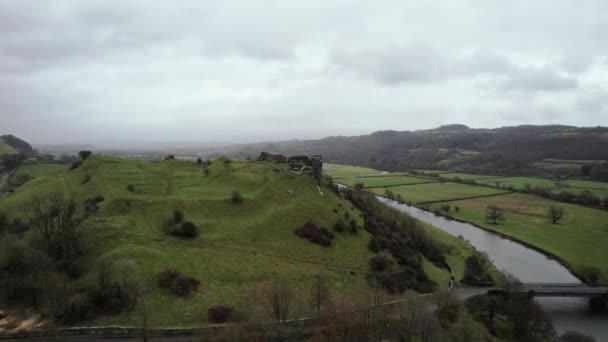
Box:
[221,124,608,179]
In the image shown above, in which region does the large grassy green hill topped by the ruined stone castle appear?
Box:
[0,156,380,326]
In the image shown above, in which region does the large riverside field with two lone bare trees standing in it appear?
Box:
[432,193,608,284]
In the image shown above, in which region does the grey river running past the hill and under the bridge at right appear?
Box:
[378,196,608,342]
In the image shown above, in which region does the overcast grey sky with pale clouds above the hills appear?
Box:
[0,0,608,143]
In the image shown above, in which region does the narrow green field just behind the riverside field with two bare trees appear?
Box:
[370,182,505,203]
